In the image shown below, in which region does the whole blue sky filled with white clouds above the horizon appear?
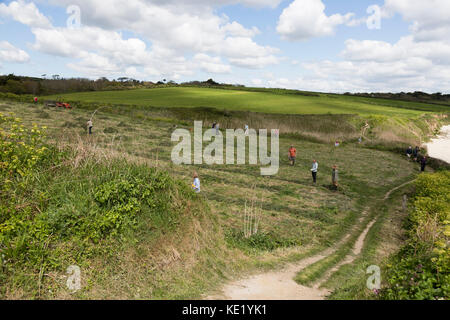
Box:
[0,0,450,92]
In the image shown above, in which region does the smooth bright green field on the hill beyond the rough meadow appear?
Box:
[43,87,448,116]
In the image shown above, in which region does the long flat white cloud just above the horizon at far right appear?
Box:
[291,50,450,92]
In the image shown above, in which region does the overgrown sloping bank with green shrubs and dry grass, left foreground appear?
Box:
[0,114,230,299]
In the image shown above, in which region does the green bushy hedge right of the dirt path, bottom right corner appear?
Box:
[381,171,450,300]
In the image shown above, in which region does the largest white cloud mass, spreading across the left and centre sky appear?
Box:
[26,0,280,76]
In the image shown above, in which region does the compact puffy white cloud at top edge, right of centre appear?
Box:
[277,0,354,41]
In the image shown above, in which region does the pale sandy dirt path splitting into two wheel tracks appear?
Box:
[206,180,414,300]
